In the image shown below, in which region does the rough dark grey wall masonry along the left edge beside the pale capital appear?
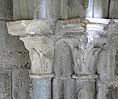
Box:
[0,0,30,99]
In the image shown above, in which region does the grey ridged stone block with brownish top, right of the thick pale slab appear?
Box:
[55,19,85,37]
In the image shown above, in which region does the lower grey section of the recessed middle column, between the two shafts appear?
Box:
[53,78,75,99]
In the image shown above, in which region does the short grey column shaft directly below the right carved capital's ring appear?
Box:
[76,80,96,99]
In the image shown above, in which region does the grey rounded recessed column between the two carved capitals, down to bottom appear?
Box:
[53,39,75,99]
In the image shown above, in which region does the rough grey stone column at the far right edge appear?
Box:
[97,21,118,99]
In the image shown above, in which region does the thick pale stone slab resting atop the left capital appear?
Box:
[7,20,54,36]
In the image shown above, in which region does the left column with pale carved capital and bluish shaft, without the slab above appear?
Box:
[21,36,54,99]
